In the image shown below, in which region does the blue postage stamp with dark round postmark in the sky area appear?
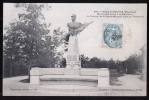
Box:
[103,24,123,48]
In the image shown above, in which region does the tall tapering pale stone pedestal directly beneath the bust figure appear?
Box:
[65,36,81,75]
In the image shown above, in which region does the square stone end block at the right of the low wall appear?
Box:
[98,68,110,87]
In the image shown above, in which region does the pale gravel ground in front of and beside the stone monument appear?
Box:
[3,74,146,96]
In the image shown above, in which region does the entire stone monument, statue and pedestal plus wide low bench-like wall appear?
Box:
[30,14,110,87]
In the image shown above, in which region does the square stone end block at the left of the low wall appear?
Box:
[30,68,40,84]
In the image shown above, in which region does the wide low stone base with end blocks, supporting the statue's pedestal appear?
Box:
[30,67,110,88]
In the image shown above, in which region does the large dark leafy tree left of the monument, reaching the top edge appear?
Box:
[3,3,62,76]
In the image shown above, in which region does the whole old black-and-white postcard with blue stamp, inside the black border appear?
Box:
[2,3,147,96]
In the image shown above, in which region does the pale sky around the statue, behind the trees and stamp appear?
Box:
[3,3,147,61]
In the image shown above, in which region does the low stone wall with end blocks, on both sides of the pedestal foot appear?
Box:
[30,68,110,87]
